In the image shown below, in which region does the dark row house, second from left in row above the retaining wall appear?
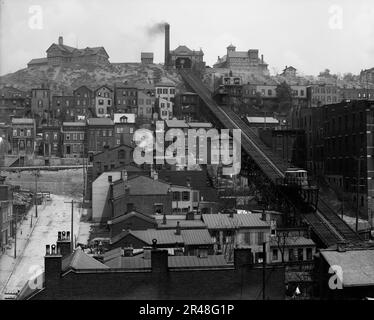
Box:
[40,124,62,157]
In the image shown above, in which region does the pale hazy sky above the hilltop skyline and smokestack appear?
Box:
[0,0,374,75]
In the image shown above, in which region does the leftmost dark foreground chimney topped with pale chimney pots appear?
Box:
[44,244,62,291]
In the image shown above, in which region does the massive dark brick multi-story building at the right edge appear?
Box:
[321,101,374,225]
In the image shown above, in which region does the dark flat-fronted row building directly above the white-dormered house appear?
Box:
[114,84,138,113]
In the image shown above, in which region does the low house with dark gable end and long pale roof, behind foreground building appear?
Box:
[110,225,214,256]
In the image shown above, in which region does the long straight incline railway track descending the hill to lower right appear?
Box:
[180,70,362,247]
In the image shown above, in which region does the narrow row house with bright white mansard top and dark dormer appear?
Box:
[113,113,136,146]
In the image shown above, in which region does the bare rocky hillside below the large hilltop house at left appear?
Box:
[0,63,183,94]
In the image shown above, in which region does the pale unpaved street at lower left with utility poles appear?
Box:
[0,195,88,300]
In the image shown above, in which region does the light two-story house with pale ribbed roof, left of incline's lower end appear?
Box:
[202,213,275,263]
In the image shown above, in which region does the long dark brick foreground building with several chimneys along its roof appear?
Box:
[17,232,285,300]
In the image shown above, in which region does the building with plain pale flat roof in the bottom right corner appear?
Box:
[317,244,374,300]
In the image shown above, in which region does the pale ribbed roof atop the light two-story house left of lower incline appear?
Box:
[202,213,270,229]
